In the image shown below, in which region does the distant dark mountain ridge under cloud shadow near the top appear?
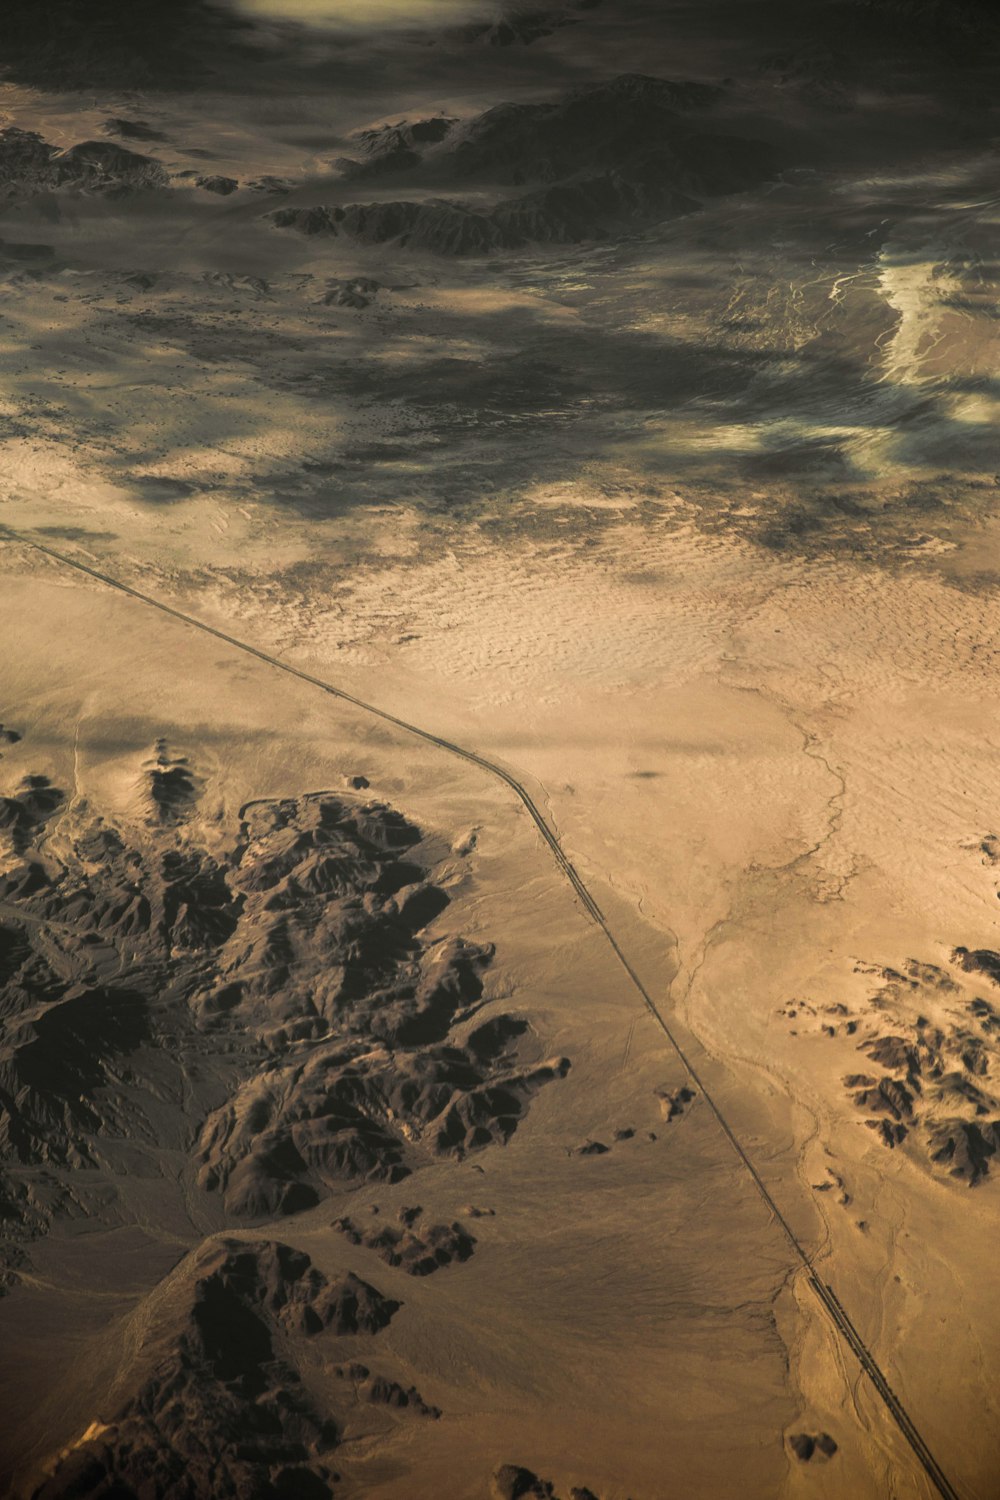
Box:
[268,74,777,255]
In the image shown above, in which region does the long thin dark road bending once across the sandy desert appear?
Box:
[0,527,961,1500]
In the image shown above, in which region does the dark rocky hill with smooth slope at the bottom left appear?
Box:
[36,1239,413,1500]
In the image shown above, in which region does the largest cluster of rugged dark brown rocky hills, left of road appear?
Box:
[0,741,568,1272]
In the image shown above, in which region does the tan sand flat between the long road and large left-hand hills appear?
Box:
[4,579,869,1496]
